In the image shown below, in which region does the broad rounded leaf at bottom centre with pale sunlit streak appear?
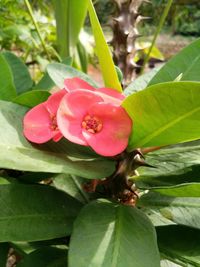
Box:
[69,200,160,267]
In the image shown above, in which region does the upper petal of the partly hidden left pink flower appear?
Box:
[44,89,67,115]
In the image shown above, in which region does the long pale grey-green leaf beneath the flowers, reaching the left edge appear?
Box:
[0,101,115,179]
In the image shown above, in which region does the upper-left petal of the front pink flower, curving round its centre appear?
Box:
[57,89,103,145]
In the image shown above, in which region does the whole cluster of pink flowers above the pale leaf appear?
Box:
[24,78,132,156]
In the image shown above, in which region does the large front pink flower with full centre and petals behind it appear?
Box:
[57,88,132,156]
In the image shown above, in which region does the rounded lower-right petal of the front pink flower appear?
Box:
[82,103,132,156]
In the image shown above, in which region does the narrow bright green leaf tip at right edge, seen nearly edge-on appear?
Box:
[153,183,200,198]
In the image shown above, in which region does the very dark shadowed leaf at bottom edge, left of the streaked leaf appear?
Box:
[17,247,67,267]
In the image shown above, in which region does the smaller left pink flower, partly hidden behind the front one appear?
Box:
[23,89,67,144]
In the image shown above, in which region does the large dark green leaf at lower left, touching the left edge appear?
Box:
[0,184,81,242]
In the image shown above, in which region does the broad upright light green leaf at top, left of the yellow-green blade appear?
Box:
[53,0,88,58]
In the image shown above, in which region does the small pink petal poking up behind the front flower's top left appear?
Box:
[64,77,95,92]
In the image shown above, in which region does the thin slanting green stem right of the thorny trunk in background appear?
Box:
[140,0,173,74]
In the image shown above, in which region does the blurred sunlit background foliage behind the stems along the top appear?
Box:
[0,0,200,81]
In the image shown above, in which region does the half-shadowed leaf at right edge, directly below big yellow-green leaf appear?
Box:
[136,141,200,189]
